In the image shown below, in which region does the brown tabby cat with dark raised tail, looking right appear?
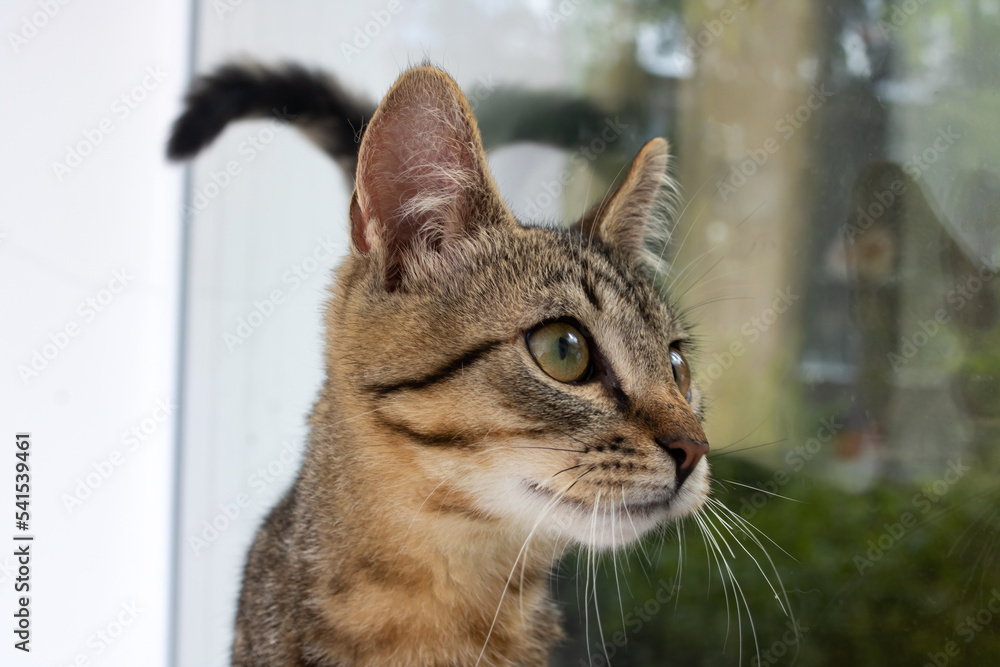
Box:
[169,65,710,667]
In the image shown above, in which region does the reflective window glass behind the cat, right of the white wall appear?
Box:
[178,0,1000,665]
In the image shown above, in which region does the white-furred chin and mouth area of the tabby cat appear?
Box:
[522,474,708,549]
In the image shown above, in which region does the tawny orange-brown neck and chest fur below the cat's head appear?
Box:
[301,388,561,666]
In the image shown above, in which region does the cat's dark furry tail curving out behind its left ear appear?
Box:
[167,64,375,176]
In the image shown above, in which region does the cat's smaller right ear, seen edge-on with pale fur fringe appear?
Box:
[574,138,677,264]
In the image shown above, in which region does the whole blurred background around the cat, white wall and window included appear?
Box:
[0,0,1000,667]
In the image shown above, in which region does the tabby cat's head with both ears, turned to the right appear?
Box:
[327,67,709,546]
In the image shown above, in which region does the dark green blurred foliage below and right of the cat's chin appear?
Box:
[553,457,1000,667]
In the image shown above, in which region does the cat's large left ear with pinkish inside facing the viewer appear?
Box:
[351,66,509,288]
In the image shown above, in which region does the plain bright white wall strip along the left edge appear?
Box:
[0,0,189,667]
